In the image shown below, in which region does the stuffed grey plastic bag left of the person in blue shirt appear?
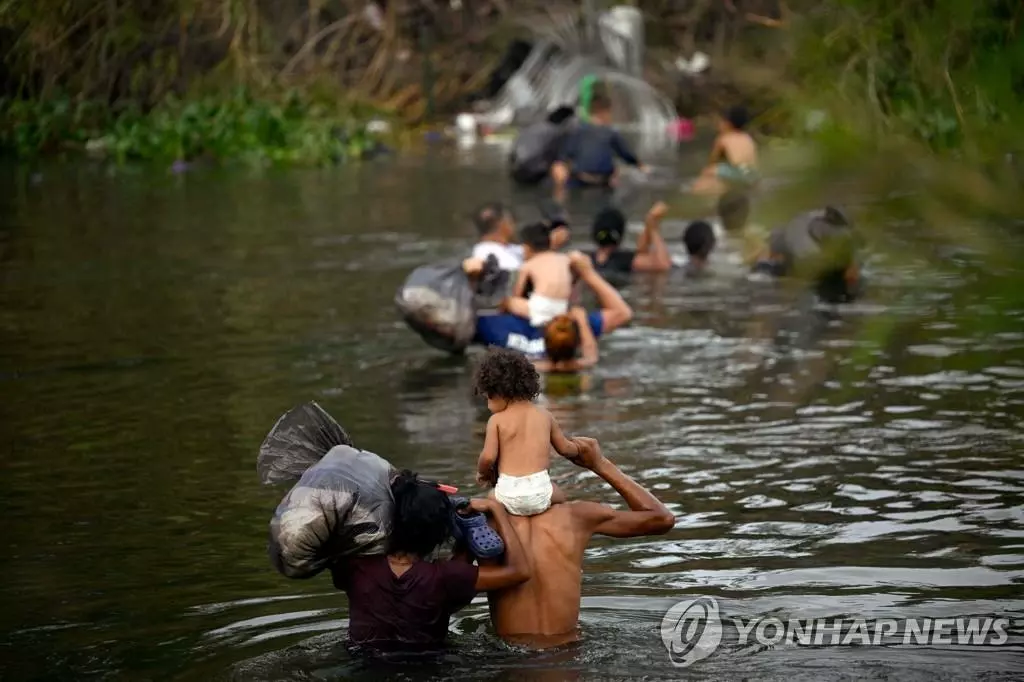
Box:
[394,254,476,353]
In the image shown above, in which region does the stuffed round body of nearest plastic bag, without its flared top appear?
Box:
[268,445,396,579]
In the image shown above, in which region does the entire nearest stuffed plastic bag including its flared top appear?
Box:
[257,403,396,579]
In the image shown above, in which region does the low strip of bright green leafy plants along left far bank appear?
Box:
[0,90,389,165]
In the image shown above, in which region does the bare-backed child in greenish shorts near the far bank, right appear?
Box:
[692,106,758,195]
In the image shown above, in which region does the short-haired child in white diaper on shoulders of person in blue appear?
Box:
[505,223,572,327]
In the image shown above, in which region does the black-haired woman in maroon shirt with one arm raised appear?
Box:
[331,471,529,650]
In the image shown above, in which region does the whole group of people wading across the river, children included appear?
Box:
[333,95,856,650]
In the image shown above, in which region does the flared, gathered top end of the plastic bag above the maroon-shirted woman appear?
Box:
[256,402,352,485]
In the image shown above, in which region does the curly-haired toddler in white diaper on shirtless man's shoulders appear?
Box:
[476,349,580,516]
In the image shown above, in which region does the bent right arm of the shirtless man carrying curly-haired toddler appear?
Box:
[573,437,676,538]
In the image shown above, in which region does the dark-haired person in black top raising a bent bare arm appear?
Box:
[588,202,672,276]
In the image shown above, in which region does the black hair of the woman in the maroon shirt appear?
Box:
[388,469,452,557]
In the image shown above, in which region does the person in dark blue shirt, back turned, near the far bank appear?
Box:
[551,93,647,203]
